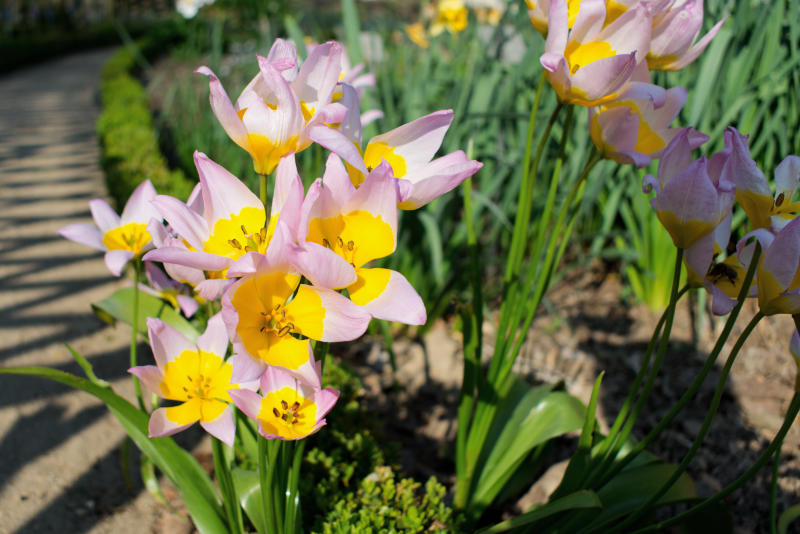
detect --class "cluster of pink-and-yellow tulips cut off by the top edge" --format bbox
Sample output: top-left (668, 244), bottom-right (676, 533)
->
top-left (527, 0), bottom-right (724, 167)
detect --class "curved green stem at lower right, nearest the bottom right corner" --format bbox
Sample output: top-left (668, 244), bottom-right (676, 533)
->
top-left (598, 312), bottom-right (764, 532)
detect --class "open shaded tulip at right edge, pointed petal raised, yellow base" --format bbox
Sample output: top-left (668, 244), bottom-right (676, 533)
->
top-left (725, 128), bottom-right (800, 230)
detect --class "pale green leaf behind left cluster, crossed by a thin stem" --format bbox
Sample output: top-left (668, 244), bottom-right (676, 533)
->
top-left (92, 287), bottom-right (199, 342)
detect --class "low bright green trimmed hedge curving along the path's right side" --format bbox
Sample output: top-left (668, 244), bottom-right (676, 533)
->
top-left (97, 30), bottom-right (195, 208)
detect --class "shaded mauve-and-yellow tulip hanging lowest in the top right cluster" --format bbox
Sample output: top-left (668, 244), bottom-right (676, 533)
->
top-left (589, 84), bottom-right (692, 167)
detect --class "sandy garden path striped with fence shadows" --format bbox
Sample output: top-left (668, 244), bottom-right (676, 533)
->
top-left (0, 50), bottom-right (169, 534)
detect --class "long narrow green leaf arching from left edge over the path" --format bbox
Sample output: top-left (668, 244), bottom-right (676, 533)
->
top-left (0, 367), bottom-right (227, 534)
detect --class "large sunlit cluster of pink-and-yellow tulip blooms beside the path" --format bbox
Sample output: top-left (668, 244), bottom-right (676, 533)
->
top-left (61, 39), bottom-right (481, 445)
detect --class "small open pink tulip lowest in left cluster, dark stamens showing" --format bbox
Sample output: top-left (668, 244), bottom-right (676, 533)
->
top-left (230, 367), bottom-right (339, 440)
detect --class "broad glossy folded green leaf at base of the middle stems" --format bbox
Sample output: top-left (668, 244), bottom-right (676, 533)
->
top-left (471, 379), bottom-right (585, 510)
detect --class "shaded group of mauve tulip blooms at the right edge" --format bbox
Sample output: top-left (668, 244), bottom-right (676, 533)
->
top-left (643, 128), bottom-right (800, 315)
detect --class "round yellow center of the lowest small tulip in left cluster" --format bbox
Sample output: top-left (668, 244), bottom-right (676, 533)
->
top-left (258, 387), bottom-right (317, 439)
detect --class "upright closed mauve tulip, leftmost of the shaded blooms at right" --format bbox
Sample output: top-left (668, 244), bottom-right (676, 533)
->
top-left (643, 128), bottom-right (734, 249)
